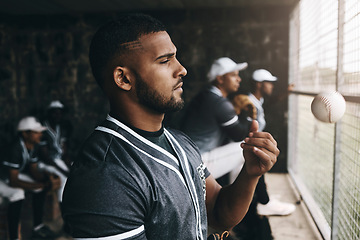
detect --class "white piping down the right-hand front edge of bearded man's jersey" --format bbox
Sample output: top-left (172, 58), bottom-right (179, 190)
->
top-left (164, 129), bottom-right (204, 240)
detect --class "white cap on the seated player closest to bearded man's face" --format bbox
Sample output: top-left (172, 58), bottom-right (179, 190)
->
top-left (208, 57), bottom-right (248, 81)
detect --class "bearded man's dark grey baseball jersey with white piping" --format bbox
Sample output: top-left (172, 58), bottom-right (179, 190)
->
top-left (63, 116), bottom-right (209, 240)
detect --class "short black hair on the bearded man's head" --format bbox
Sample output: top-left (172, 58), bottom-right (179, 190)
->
top-left (89, 13), bottom-right (166, 87)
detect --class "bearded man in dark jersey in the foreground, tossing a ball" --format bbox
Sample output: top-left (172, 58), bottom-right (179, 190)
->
top-left (63, 14), bottom-right (279, 240)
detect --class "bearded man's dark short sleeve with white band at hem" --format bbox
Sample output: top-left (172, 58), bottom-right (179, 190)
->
top-left (63, 158), bottom-right (146, 239)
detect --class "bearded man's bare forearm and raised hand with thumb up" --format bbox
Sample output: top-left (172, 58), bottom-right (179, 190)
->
top-left (206, 121), bottom-right (280, 230)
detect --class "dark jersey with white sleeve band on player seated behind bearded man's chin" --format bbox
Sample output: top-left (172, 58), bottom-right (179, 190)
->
top-left (181, 86), bottom-right (250, 153)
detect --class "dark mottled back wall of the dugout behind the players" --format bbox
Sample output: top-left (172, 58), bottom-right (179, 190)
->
top-left (0, 6), bottom-right (291, 171)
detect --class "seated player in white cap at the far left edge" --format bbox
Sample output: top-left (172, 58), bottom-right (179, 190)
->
top-left (0, 117), bottom-right (60, 240)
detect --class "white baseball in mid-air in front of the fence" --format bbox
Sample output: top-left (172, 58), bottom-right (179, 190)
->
top-left (311, 91), bottom-right (346, 123)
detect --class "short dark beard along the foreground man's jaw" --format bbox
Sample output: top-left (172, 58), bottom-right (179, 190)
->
top-left (135, 72), bottom-right (184, 113)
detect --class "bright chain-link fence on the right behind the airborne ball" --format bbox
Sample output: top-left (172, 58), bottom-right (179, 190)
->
top-left (288, 0), bottom-right (360, 240)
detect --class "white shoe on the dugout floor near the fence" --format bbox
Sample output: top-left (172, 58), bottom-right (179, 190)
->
top-left (257, 199), bottom-right (296, 216)
